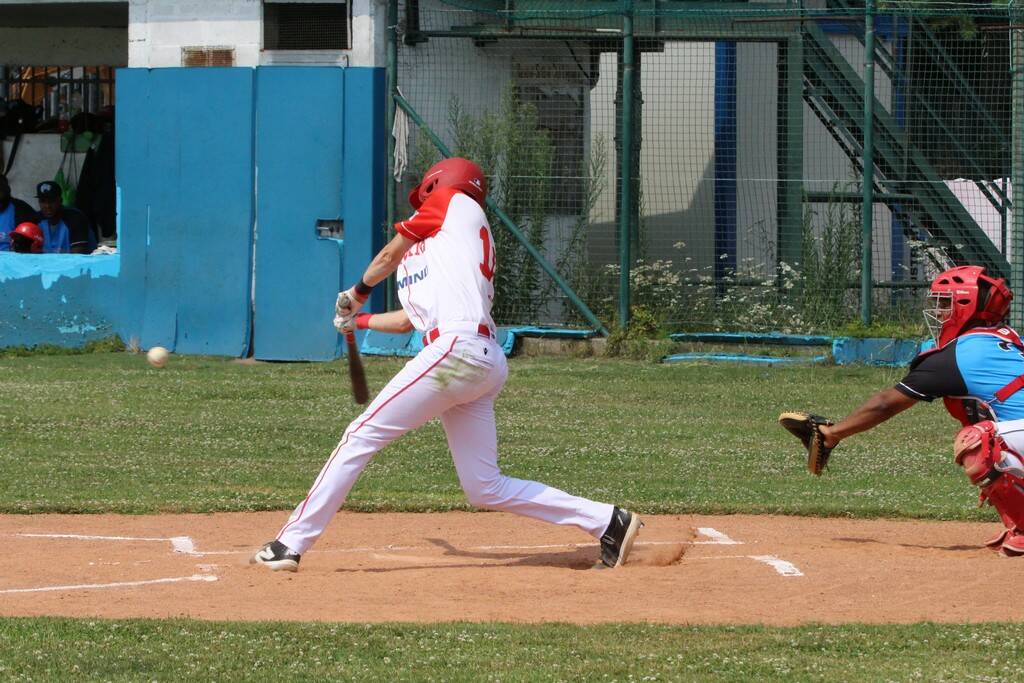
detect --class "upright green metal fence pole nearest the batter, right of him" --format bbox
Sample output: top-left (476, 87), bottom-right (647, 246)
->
top-left (618, 0), bottom-right (635, 330)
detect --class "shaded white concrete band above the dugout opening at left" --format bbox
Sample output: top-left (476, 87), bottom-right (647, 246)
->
top-left (0, 27), bottom-right (128, 67)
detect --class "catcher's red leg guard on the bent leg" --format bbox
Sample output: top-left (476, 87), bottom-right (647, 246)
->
top-left (953, 421), bottom-right (1024, 535)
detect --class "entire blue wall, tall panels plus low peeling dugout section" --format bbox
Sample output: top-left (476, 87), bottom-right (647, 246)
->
top-left (0, 67), bottom-right (385, 359)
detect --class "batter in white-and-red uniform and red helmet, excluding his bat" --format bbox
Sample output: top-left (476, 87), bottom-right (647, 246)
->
top-left (252, 158), bottom-right (642, 571)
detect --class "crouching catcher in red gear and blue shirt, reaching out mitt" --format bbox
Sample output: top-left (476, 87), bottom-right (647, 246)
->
top-left (779, 265), bottom-right (1024, 556)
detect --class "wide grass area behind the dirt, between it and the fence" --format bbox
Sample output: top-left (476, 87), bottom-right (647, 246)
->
top-left (0, 353), bottom-right (974, 519)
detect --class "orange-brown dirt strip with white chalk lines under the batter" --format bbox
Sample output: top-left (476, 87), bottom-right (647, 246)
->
top-left (0, 513), bottom-right (1024, 625)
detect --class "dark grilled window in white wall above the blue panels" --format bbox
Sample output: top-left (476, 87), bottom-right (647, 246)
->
top-left (263, 0), bottom-right (351, 51)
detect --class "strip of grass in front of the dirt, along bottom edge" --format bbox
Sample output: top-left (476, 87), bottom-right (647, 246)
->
top-left (0, 618), bottom-right (1024, 682)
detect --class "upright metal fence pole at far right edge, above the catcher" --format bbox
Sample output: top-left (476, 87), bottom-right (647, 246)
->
top-left (1007, 1), bottom-right (1024, 327)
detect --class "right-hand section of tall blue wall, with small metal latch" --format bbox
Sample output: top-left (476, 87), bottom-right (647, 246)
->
top-left (254, 67), bottom-right (384, 360)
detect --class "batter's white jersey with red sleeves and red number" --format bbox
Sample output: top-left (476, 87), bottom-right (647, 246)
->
top-left (394, 187), bottom-right (496, 333)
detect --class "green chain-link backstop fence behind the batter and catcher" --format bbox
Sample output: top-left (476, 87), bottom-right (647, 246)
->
top-left (393, 0), bottom-right (1024, 333)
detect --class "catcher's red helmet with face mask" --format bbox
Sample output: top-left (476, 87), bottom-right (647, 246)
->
top-left (925, 265), bottom-right (1014, 346)
